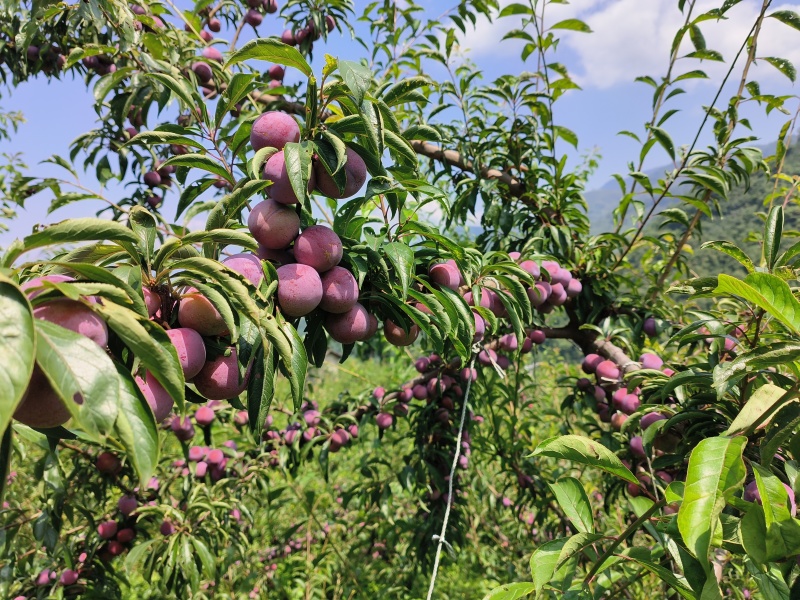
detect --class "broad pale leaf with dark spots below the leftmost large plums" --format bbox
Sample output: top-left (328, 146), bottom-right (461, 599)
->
top-left (35, 319), bottom-right (120, 442)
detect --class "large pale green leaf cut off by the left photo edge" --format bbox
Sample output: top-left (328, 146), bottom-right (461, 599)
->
top-left (0, 274), bottom-right (36, 432)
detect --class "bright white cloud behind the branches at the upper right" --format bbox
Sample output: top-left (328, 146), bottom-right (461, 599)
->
top-left (465, 0), bottom-right (800, 88)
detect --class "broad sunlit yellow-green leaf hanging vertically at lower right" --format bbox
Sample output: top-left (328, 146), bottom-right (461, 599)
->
top-left (678, 436), bottom-right (747, 570)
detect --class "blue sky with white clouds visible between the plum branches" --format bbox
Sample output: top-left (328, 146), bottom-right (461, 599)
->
top-left (0, 0), bottom-right (800, 246)
